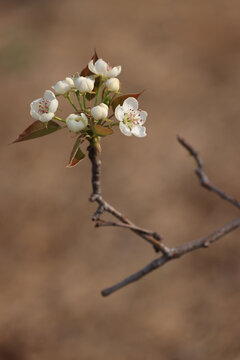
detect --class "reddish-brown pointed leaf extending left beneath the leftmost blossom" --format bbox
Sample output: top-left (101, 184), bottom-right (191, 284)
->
top-left (13, 120), bottom-right (62, 144)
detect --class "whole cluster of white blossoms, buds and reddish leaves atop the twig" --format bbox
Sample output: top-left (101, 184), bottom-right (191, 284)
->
top-left (16, 52), bottom-right (147, 166)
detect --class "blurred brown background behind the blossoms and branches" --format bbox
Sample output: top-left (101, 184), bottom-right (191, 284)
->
top-left (0, 0), bottom-right (240, 360)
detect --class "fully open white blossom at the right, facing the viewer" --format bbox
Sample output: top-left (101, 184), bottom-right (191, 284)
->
top-left (115, 97), bottom-right (147, 137)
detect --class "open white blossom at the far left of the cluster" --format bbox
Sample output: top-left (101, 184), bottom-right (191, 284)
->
top-left (30, 90), bottom-right (58, 122)
